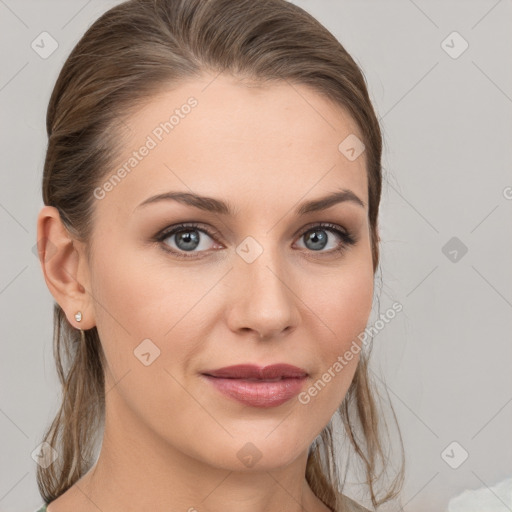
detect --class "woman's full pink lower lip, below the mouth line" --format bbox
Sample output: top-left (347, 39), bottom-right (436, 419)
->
top-left (203, 375), bottom-right (307, 407)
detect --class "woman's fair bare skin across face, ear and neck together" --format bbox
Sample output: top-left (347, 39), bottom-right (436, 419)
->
top-left (38, 75), bottom-right (373, 512)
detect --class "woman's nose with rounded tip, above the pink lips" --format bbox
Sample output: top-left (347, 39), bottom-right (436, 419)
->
top-left (227, 243), bottom-right (300, 340)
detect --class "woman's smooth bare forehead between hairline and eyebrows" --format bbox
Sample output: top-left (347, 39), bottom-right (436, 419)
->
top-left (96, 75), bottom-right (368, 216)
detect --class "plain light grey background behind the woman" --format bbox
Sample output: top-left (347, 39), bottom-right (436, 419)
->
top-left (0, 0), bottom-right (512, 512)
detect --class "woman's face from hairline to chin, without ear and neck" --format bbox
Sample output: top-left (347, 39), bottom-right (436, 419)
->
top-left (86, 75), bottom-right (373, 471)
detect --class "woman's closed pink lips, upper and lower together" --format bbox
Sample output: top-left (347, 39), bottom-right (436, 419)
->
top-left (203, 364), bottom-right (308, 407)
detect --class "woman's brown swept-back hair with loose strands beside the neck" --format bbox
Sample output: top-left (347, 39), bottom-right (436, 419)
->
top-left (37, 0), bottom-right (404, 511)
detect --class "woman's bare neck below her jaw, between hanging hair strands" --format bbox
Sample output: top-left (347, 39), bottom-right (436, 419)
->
top-left (70, 392), bottom-right (329, 512)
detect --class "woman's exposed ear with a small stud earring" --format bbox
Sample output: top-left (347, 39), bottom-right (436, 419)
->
top-left (37, 206), bottom-right (96, 330)
